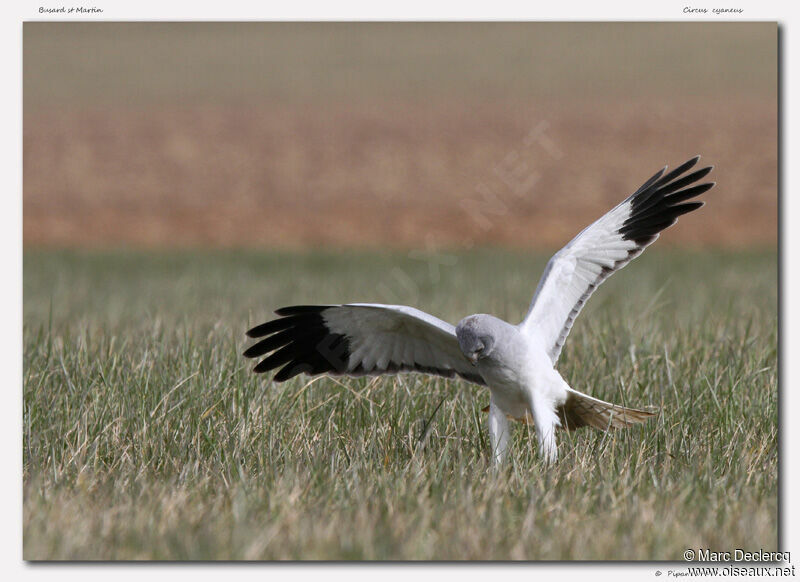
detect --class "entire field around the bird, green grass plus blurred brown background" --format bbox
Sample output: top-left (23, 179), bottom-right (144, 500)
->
top-left (23, 23), bottom-right (778, 560)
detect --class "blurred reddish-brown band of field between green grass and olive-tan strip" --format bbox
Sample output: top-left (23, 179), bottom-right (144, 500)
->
top-left (24, 100), bottom-right (777, 248)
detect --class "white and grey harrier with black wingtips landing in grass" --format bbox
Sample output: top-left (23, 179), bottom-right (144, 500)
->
top-left (244, 156), bottom-right (714, 463)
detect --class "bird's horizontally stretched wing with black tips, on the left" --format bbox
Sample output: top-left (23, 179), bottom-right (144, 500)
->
top-left (244, 303), bottom-right (485, 385)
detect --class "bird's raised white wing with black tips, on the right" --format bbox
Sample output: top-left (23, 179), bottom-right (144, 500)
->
top-left (520, 156), bottom-right (714, 364)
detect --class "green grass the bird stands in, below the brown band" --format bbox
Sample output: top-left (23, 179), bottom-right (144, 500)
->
top-left (23, 248), bottom-right (778, 560)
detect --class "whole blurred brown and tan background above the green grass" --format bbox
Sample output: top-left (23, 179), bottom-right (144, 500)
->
top-left (23, 23), bottom-right (778, 249)
